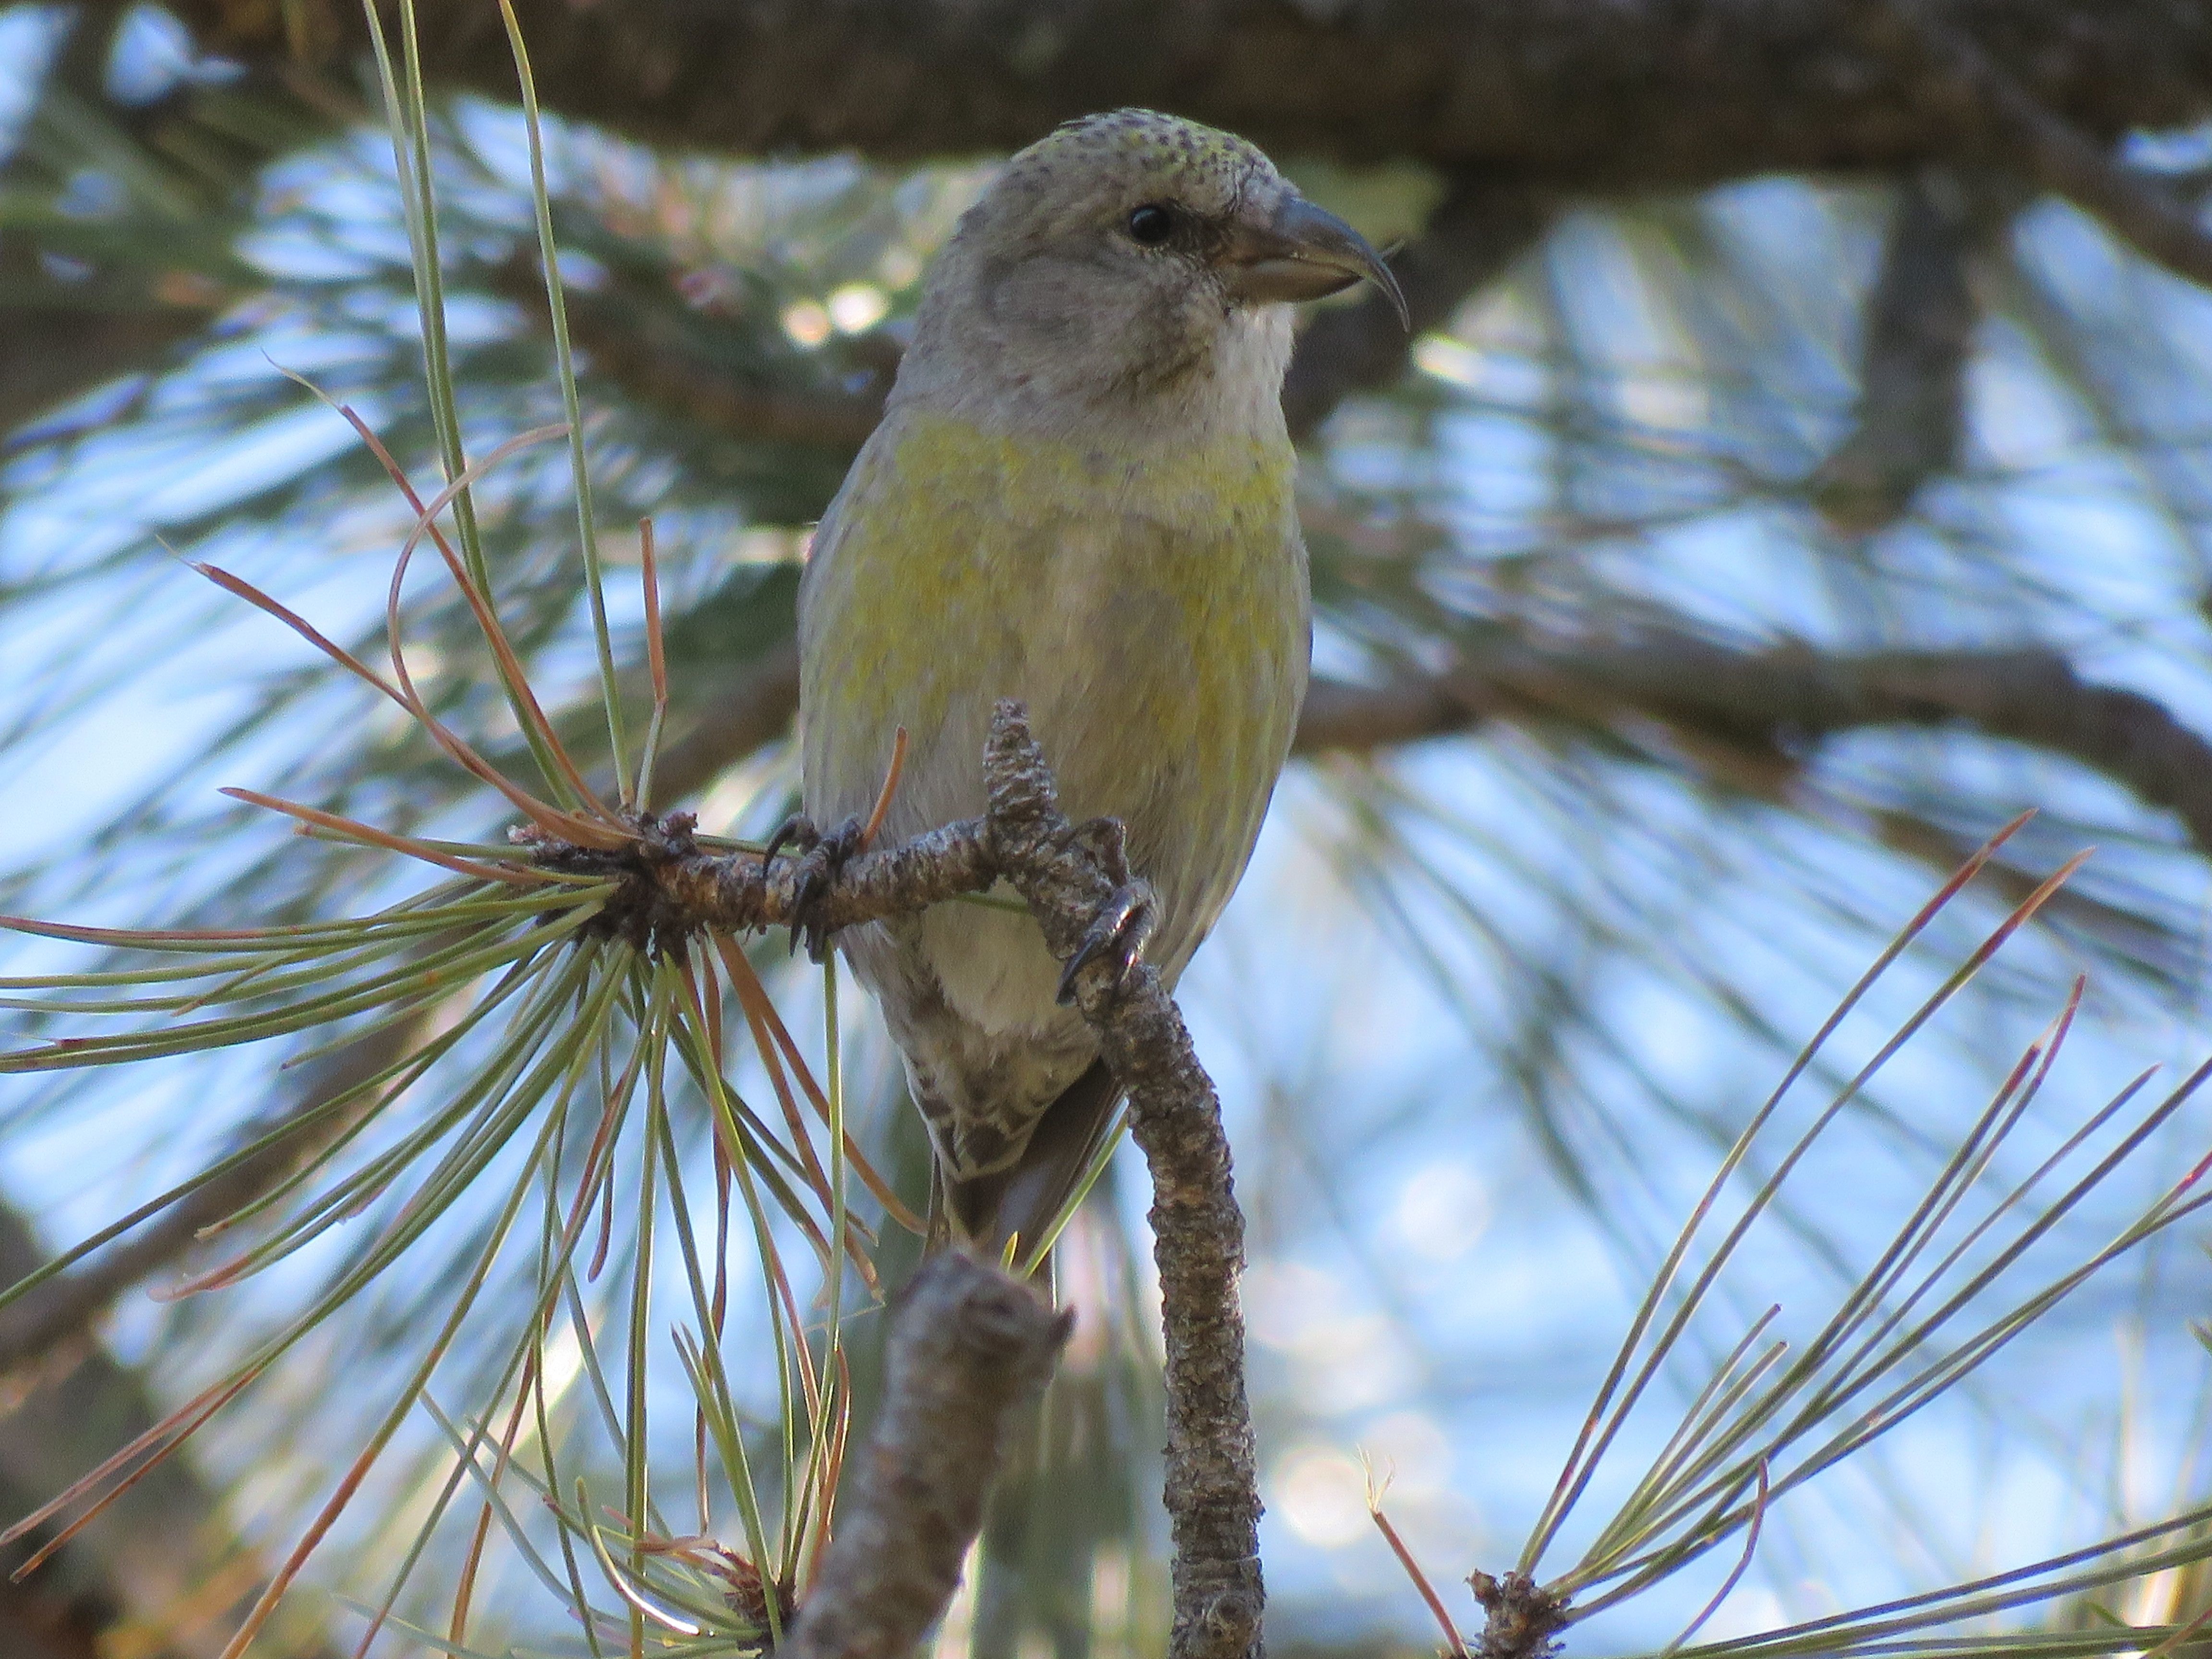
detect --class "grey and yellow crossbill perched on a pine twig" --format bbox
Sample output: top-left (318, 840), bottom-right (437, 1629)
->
top-left (798, 110), bottom-right (1405, 1250)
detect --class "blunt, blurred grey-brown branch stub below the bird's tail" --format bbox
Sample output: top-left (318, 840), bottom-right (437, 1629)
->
top-left (781, 1252), bottom-right (1073, 1659)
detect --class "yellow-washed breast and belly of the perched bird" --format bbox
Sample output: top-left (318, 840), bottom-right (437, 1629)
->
top-left (801, 409), bottom-right (1310, 947)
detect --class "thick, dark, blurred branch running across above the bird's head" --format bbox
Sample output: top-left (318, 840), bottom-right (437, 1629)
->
top-left (143, 0), bottom-right (2212, 188)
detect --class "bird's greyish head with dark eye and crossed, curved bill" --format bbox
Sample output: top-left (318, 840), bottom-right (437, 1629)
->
top-left (909, 108), bottom-right (1405, 429)
